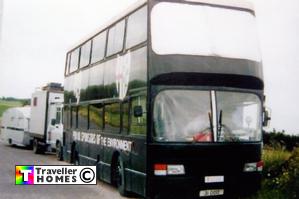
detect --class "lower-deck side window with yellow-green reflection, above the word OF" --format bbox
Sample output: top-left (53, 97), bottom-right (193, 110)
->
top-left (89, 104), bottom-right (103, 130)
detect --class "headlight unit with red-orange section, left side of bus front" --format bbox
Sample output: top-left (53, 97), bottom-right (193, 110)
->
top-left (154, 164), bottom-right (185, 176)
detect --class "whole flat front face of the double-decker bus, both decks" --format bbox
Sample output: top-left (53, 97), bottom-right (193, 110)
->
top-left (147, 0), bottom-right (264, 198)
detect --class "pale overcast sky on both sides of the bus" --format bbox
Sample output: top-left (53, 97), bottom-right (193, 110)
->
top-left (0, 0), bottom-right (299, 134)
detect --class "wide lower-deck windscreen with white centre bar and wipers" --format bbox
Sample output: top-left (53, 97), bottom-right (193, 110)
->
top-left (154, 90), bottom-right (261, 142)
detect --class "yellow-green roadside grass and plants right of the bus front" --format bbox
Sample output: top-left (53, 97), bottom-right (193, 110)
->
top-left (250, 145), bottom-right (299, 199)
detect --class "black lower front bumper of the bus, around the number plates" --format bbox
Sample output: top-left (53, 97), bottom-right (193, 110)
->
top-left (148, 172), bottom-right (261, 199)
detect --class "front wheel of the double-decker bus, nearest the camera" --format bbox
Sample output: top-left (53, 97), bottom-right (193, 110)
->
top-left (115, 157), bottom-right (129, 196)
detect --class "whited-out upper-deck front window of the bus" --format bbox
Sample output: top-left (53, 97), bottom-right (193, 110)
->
top-left (151, 1), bottom-right (261, 62)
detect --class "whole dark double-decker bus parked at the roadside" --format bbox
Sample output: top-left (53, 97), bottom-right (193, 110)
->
top-left (64, 0), bottom-right (267, 198)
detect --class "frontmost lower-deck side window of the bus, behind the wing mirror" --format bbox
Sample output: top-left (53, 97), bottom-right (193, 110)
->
top-left (130, 96), bottom-right (147, 135)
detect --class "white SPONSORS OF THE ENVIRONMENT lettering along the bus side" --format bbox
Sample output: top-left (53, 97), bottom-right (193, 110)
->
top-left (73, 131), bottom-right (133, 152)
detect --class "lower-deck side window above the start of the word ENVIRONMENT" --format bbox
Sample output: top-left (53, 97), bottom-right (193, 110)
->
top-left (104, 103), bottom-right (120, 133)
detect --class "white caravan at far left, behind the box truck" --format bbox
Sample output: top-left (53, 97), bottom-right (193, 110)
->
top-left (1, 106), bottom-right (31, 146)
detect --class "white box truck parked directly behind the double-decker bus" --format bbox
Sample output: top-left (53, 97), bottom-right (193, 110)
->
top-left (29, 83), bottom-right (64, 160)
